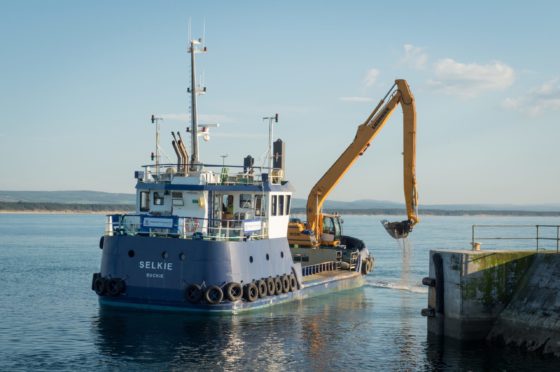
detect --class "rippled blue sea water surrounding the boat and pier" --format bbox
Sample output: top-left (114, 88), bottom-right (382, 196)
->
top-left (0, 214), bottom-right (560, 371)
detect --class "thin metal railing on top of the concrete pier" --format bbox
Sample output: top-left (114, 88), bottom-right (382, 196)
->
top-left (471, 225), bottom-right (560, 253)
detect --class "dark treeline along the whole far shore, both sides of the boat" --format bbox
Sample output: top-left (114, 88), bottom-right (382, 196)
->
top-left (0, 201), bottom-right (560, 217)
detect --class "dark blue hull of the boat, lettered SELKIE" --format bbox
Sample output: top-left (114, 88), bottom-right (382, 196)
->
top-left (92, 235), bottom-right (369, 314)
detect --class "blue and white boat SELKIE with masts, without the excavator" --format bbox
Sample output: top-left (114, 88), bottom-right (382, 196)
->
top-left (91, 39), bottom-right (373, 313)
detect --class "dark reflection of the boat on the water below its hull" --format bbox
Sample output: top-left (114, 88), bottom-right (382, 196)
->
top-left (92, 289), bottom-right (372, 369)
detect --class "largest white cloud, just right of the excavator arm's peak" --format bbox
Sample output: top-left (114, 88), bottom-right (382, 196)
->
top-left (429, 58), bottom-right (515, 97)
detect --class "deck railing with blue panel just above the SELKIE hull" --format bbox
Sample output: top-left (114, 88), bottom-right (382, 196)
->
top-left (105, 214), bottom-right (268, 241)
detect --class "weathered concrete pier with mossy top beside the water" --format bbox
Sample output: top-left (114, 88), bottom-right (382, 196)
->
top-left (422, 250), bottom-right (560, 356)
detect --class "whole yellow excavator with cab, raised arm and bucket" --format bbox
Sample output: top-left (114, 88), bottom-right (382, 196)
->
top-left (288, 79), bottom-right (419, 248)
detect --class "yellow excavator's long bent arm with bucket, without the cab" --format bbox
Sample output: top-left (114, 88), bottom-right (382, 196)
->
top-left (307, 80), bottom-right (418, 238)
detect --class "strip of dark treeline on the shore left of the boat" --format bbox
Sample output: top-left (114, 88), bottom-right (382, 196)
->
top-left (0, 201), bottom-right (134, 213)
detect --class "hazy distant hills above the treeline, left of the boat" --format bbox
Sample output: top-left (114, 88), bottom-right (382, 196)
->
top-left (0, 191), bottom-right (135, 205)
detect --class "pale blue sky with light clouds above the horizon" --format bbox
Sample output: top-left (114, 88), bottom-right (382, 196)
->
top-left (0, 0), bottom-right (560, 204)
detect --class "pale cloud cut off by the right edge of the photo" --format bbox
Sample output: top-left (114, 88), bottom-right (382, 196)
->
top-left (502, 79), bottom-right (560, 115)
